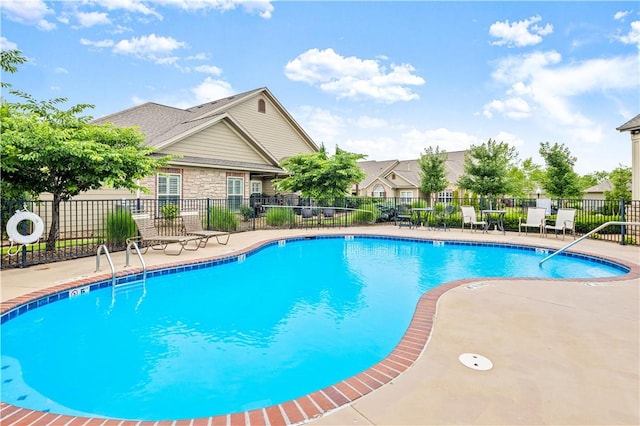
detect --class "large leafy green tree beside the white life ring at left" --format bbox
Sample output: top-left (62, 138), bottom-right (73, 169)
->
top-left (0, 92), bottom-right (169, 250)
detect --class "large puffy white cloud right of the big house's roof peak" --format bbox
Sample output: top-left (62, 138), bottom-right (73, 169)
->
top-left (285, 49), bottom-right (424, 103)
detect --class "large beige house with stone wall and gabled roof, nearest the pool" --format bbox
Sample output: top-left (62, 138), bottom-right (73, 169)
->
top-left (60, 88), bottom-right (318, 211)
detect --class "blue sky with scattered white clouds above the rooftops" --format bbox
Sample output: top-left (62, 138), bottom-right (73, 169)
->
top-left (0, 0), bottom-right (640, 174)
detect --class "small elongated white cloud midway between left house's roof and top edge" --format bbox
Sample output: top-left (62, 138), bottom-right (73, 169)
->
top-left (113, 34), bottom-right (187, 64)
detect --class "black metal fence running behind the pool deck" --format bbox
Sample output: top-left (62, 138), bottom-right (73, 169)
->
top-left (0, 195), bottom-right (640, 268)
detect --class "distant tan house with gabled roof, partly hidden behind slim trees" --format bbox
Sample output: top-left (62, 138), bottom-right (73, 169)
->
top-left (352, 151), bottom-right (466, 203)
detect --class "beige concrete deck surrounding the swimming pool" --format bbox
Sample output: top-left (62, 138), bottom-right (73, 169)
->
top-left (0, 225), bottom-right (640, 425)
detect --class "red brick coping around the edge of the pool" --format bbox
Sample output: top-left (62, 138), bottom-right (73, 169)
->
top-left (0, 234), bottom-right (640, 426)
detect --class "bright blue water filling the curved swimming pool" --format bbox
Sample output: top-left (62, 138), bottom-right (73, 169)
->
top-left (1, 237), bottom-right (626, 420)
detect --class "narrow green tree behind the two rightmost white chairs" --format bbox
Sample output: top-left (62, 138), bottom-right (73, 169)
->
top-left (540, 142), bottom-right (582, 198)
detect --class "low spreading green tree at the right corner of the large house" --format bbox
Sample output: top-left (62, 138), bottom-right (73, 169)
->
top-left (274, 145), bottom-right (365, 200)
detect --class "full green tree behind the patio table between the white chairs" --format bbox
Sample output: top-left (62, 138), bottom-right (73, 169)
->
top-left (458, 139), bottom-right (517, 206)
